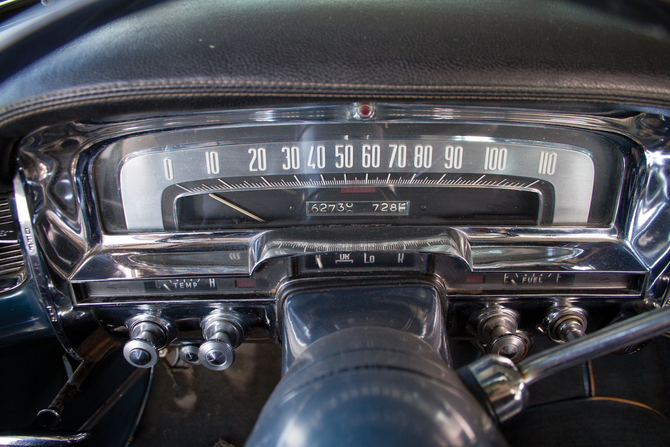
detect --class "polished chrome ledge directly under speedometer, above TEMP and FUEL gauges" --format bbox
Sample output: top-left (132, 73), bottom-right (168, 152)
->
top-left (61, 227), bottom-right (632, 282)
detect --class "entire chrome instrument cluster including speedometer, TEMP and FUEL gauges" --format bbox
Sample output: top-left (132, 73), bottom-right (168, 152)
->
top-left (16, 102), bottom-right (656, 342)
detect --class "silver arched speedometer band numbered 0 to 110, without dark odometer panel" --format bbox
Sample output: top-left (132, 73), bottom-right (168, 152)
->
top-left (107, 126), bottom-right (600, 233)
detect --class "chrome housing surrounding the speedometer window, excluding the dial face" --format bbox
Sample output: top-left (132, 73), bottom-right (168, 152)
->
top-left (15, 103), bottom-right (669, 357)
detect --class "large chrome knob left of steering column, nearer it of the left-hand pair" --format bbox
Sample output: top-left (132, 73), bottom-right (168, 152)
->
top-left (198, 315), bottom-right (244, 371)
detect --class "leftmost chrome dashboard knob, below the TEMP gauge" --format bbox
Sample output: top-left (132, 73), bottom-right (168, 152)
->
top-left (123, 321), bottom-right (167, 368)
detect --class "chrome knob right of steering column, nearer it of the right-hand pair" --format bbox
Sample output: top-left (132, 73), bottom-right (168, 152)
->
top-left (472, 306), bottom-right (531, 362)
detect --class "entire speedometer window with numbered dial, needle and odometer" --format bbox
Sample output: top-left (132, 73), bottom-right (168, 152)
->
top-left (96, 124), bottom-right (622, 231)
